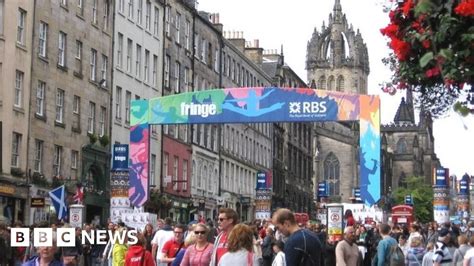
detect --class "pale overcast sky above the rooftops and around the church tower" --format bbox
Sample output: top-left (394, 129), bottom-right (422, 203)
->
top-left (197, 0), bottom-right (474, 177)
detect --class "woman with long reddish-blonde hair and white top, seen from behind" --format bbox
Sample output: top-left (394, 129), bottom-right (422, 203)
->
top-left (218, 224), bottom-right (259, 266)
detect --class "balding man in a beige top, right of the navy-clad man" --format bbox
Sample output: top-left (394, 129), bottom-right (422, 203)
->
top-left (336, 226), bottom-right (359, 266)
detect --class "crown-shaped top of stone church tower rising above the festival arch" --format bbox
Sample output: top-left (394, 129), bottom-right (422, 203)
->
top-left (306, 0), bottom-right (370, 94)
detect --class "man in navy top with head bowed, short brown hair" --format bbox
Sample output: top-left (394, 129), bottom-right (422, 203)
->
top-left (273, 208), bottom-right (321, 266)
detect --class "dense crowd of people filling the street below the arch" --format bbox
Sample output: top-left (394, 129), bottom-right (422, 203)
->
top-left (0, 208), bottom-right (474, 266)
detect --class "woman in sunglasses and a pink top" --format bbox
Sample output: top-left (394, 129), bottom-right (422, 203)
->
top-left (181, 224), bottom-right (214, 266)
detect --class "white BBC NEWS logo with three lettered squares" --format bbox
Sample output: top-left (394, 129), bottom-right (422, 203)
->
top-left (10, 228), bottom-right (138, 247)
